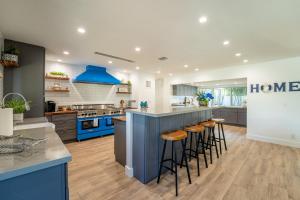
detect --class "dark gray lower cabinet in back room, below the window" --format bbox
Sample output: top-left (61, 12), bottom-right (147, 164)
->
top-left (212, 108), bottom-right (247, 126)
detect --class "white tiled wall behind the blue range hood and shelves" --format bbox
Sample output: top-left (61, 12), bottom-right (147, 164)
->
top-left (45, 61), bottom-right (155, 108)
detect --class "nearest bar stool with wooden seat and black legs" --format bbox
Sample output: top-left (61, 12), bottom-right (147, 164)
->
top-left (157, 130), bottom-right (192, 196)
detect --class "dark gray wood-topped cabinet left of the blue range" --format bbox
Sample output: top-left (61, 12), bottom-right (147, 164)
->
top-left (47, 113), bottom-right (77, 141)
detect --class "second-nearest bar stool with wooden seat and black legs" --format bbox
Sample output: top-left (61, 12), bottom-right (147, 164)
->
top-left (180, 125), bottom-right (208, 176)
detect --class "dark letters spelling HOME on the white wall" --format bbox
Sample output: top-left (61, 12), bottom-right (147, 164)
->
top-left (250, 81), bottom-right (300, 93)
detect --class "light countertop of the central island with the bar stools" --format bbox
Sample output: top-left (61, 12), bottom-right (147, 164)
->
top-left (126, 106), bottom-right (215, 117)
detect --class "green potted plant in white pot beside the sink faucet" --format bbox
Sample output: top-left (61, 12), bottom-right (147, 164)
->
top-left (5, 99), bottom-right (26, 121)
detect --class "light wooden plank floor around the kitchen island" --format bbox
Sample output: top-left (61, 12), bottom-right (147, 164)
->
top-left (67, 126), bottom-right (300, 200)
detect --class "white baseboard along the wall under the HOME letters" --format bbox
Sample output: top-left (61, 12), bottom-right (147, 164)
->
top-left (247, 133), bottom-right (300, 148)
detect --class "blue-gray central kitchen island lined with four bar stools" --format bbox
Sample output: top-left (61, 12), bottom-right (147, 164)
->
top-left (125, 106), bottom-right (213, 184)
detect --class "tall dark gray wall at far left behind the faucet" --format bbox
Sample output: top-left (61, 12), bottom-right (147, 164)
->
top-left (3, 39), bottom-right (45, 117)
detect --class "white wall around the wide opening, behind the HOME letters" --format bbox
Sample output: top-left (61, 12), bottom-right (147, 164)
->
top-left (160, 57), bottom-right (300, 147)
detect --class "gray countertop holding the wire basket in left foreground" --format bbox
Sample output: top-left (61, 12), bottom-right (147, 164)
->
top-left (0, 127), bottom-right (71, 181)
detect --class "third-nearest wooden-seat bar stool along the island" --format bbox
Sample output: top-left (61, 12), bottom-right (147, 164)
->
top-left (200, 121), bottom-right (219, 164)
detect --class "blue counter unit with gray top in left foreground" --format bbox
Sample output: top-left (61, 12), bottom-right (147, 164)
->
top-left (0, 127), bottom-right (71, 200)
